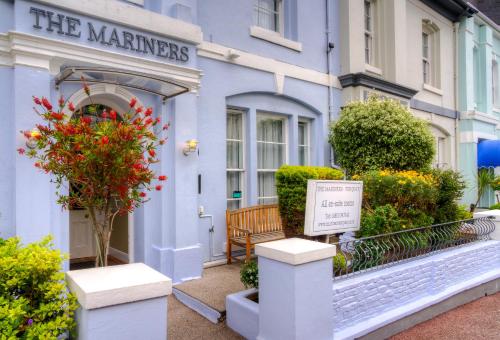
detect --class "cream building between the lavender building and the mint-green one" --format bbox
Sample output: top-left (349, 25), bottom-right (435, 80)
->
top-left (339, 0), bottom-right (475, 173)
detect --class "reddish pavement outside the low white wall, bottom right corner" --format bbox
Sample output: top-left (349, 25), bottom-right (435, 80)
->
top-left (391, 293), bottom-right (500, 340)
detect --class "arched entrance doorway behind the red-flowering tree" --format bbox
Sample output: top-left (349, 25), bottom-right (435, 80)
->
top-left (69, 88), bottom-right (140, 270)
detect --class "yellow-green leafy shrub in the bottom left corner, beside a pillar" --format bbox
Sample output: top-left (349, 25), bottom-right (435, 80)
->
top-left (0, 237), bottom-right (77, 339)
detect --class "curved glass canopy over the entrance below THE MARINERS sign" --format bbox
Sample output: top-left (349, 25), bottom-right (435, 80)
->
top-left (55, 66), bottom-right (191, 100)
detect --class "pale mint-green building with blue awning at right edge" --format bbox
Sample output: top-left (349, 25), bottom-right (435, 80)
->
top-left (457, 1), bottom-right (500, 207)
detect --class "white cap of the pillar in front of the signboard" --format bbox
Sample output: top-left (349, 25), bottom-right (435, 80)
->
top-left (255, 238), bottom-right (335, 266)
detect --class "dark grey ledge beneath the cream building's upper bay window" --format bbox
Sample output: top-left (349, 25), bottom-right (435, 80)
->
top-left (339, 72), bottom-right (418, 99)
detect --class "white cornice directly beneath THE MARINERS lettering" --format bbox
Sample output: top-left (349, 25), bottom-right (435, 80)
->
top-left (0, 31), bottom-right (201, 91)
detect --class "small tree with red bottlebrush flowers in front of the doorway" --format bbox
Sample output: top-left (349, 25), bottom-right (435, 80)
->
top-left (17, 84), bottom-right (169, 267)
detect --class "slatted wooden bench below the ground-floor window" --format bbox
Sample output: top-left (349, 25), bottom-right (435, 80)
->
top-left (226, 204), bottom-right (285, 264)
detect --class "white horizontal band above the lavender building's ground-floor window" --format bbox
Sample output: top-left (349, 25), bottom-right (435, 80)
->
top-left (198, 41), bottom-right (342, 89)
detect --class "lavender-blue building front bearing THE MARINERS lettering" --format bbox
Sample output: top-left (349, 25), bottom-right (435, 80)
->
top-left (0, 0), bottom-right (340, 282)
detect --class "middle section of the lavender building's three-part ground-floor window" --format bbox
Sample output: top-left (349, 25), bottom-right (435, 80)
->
top-left (257, 114), bottom-right (287, 204)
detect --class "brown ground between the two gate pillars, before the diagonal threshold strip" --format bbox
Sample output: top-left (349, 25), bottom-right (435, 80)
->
top-left (168, 295), bottom-right (243, 340)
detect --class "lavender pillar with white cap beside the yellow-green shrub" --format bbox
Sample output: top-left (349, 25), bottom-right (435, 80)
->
top-left (66, 263), bottom-right (172, 340)
